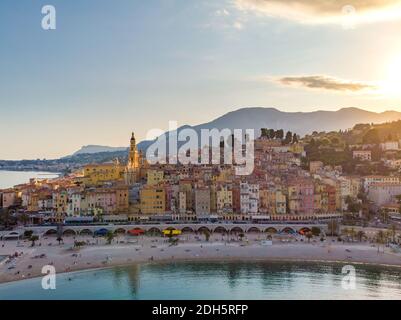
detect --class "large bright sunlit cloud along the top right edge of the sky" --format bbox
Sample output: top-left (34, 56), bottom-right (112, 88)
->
top-left (233, 0), bottom-right (401, 24)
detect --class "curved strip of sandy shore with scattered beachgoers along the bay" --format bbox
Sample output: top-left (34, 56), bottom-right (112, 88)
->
top-left (0, 235), bottom-right (401, 284)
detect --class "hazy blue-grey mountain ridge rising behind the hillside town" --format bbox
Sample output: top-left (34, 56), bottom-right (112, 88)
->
top-left (138, 108), bottom-right (401, 150)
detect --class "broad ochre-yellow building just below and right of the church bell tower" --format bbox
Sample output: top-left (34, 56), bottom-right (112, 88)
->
top-left (140, 186), bottom-right (166, 214)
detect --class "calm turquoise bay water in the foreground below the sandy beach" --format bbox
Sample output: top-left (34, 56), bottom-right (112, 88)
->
top-left (0, 262), bottom-right (401, 300)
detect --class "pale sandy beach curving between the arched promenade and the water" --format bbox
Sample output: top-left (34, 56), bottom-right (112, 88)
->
top-left (0, 235), bottom-right (401, 283)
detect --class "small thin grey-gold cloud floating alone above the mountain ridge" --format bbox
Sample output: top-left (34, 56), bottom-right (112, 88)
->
top-left (275, 75), bottom-right (376, 92)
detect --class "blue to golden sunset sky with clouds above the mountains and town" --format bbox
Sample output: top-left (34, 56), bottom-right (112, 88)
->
top-left (0, 0), bottom-right (401, 159)
